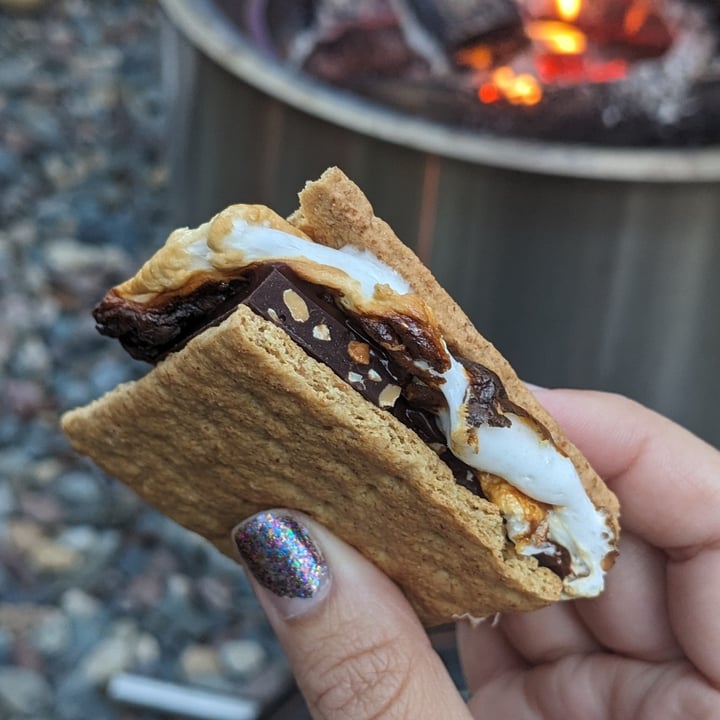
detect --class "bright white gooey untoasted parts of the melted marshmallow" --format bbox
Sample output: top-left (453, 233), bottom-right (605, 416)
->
top-left (193, 219), bottom-right (614, 597)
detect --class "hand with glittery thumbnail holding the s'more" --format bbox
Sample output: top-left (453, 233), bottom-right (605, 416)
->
top-left (232, 390), bottom-right (720, 720)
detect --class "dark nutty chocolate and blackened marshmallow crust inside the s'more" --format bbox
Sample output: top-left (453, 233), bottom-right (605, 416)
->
top-left (93, 263), bottom-right (570, 577)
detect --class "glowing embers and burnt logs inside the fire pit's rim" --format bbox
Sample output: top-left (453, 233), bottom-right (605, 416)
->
top-left (226, 0), bottom-right (720, 147)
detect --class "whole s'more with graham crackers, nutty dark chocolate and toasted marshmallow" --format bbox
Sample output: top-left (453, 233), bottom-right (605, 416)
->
top-left (62, 168), bottom-right (619, 626)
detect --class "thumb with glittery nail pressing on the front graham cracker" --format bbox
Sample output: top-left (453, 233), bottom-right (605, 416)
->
top-left (233, 510), bottom-right (470, 720)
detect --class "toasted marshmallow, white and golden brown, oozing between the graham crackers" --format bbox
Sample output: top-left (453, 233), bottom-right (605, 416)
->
top-left (120, 216), bottom-right (616, 598)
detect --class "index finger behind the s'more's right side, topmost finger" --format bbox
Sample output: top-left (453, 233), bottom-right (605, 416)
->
top-left (533, 388), bottom-right (720, 550)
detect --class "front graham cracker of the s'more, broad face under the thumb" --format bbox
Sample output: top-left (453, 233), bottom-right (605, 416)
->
top-left (62, 306), bottom-right (562, 625)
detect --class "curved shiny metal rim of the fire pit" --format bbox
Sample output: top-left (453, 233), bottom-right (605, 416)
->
top-left (160, 0), bottom-right (720, 183)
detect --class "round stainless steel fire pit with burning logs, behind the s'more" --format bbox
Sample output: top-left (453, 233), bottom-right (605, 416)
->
top-left (156, 0), bottom-right (720, 443)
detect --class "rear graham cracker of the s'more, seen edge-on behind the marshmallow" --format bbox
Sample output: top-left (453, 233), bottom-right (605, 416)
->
top-left (288, 168), bottom-right (620, 537)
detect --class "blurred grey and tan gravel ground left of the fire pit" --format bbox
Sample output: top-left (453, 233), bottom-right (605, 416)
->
top-left (0, 0), bottom-right (298, 720)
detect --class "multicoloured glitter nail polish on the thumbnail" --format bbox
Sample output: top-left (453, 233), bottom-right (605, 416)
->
top-left (233, 512), bottom-right (328, 598)
